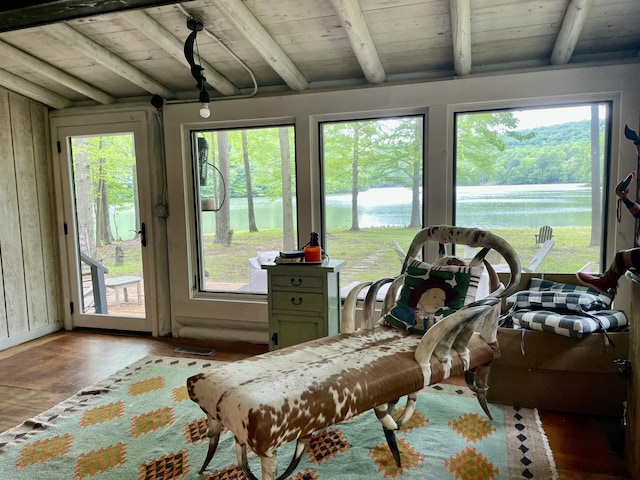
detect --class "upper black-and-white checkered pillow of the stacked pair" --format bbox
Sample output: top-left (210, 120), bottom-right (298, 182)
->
top-left (507, 278), bottom-right (613, 313)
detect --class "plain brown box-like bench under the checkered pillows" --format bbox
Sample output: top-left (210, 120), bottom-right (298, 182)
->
top-left (487, 328), bottom-right (629, 417)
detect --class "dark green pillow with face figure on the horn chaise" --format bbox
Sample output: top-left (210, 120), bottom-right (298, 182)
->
top-left (383, 258), bottom-right (484, 334)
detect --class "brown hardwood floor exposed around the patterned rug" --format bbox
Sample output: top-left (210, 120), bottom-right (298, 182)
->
top-left (0, 330), bottom-right (631, 480)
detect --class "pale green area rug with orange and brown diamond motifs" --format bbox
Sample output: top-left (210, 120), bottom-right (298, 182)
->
top-left (0, 357), bottom-right (557, 480)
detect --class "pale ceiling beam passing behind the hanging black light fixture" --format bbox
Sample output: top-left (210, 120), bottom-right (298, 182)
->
top-left (120, 10), bottom-right (240, 96)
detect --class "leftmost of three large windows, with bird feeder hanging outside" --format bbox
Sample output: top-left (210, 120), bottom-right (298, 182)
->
top-left (192, 125), bottom-right (298, 293)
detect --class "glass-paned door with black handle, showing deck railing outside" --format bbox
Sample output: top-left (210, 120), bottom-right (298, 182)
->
top-left (56, 124), bottom-right (151, 331)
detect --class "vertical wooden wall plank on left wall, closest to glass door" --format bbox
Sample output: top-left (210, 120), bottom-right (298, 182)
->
top-left (30, 103), bottom-right (63, 325)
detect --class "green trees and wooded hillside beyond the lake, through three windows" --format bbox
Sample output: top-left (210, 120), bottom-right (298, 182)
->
top-left (219, 114), bottom-right (605, 198)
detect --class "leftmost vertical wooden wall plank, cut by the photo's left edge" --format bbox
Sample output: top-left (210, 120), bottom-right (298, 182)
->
top-left (0, 89), bottom-right (29, 337)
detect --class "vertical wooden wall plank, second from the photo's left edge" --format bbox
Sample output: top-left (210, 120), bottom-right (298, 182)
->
top-left (9, 94), bottom-right (48, 330)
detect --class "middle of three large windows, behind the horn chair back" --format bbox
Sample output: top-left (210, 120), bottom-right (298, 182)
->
top-left (320, 115), bottom-right (424, 294)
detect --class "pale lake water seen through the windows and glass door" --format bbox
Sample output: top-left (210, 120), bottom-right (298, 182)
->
top-left (112, 184), bottom-right (591, 235)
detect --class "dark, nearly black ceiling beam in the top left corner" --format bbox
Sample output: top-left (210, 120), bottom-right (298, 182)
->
top-left (0, 0), bottom-right (175, 32)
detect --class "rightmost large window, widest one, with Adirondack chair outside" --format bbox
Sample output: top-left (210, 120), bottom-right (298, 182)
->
top-left (454, 103), bottom-right (610, 273)
